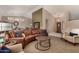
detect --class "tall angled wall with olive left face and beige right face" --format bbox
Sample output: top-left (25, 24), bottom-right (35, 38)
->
top-left (32, 8), bottom-right (56, 32)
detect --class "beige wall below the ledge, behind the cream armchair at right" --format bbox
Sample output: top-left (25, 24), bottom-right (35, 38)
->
top-left (63, 20), bottom-right (79, 33)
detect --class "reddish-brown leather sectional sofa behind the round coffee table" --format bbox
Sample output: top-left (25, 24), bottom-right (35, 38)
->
top-left (5, 29), bottom-right (40, 48)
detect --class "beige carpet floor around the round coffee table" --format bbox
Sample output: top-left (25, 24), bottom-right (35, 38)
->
top-left (24, 36), bottom-right (79, 53)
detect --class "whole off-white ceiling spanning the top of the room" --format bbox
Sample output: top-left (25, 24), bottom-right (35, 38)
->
top-left (0, 5), bottom-right (79, 19)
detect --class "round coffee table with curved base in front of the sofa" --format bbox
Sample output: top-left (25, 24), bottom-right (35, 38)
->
top-left (35, 36), bottom-right (50, 51)
